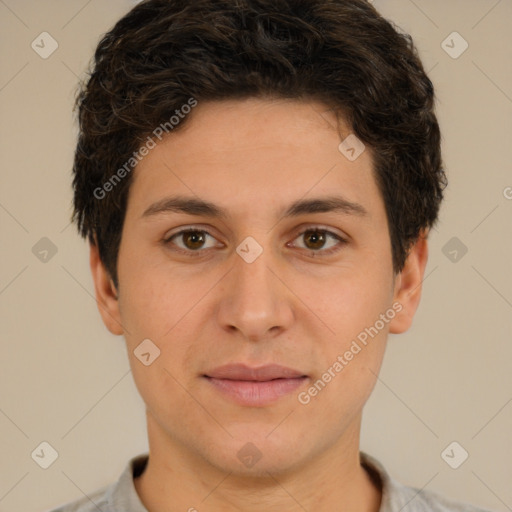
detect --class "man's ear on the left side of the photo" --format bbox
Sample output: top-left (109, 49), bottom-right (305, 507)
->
top-left (89, 243), bottom-right (124, 335)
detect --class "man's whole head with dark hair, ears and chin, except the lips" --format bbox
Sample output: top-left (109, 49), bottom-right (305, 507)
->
top-left (74, 0), bottom-right (446, 471)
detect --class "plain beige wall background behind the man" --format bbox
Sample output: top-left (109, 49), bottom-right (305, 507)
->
top-left (0, 0), bottom-right (512, 512)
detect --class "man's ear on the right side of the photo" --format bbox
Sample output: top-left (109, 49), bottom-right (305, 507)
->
top-left (389, 231), bottom-right (428, 334)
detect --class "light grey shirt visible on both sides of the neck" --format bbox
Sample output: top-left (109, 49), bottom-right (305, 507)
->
top-left (50, 452), bottom-right (494, 512)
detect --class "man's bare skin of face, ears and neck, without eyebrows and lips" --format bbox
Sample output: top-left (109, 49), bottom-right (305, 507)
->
top-left (90, 98), bottom-right (428, 512)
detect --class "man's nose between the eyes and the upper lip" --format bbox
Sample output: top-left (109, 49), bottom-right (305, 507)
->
top-left (218, 245), bottom-right (294, 341)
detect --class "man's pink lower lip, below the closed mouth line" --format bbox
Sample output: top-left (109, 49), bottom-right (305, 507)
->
top-left (206, 377), bottom-right (308, 407)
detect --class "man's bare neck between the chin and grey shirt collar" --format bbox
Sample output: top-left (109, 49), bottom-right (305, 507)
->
top-left (134, 415), bottom-right (381, 512)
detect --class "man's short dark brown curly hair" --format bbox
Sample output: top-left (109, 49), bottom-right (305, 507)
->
top-left (73, 0), bottom-right (447, 286)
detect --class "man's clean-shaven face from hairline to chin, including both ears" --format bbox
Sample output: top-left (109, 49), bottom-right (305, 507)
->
top-left (91, 99), bottom-right (426, 473)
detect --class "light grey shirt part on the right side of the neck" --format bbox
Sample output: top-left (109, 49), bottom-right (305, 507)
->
top-left (360, 452), bottom-right (496, 512)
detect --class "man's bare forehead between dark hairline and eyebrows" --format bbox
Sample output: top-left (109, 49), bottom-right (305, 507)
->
top-left (129, 99), bottom-right (383, 224)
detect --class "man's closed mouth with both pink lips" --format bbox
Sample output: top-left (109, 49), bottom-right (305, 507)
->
top-left (202, 364), bottom-right (309, 407)
